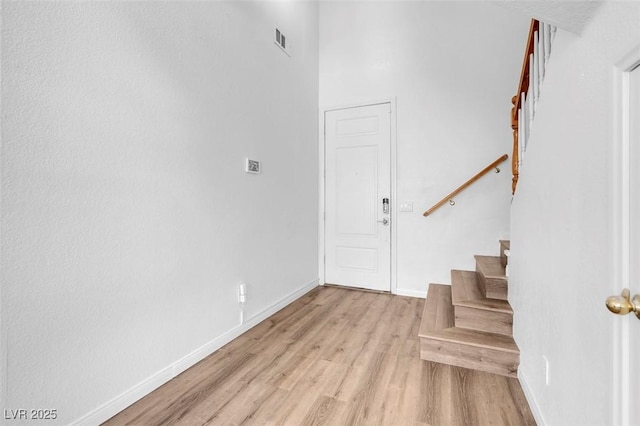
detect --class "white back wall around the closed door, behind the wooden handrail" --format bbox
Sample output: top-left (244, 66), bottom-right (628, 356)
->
top-left (320, 1), bottom-right (530, 297)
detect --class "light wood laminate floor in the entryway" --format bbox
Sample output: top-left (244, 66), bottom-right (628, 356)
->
top-left (105, 286), bottom-right (535, 426)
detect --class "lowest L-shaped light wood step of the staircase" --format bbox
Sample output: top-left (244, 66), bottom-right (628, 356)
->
top-left (419, 284), bottom-right (520, 377)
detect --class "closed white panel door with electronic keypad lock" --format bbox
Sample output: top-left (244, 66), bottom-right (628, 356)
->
top-left (325, 103), bottom-right (393, 291)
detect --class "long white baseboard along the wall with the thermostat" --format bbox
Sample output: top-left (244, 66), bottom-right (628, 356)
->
top-left (71, 280), bottom-right (318, 426)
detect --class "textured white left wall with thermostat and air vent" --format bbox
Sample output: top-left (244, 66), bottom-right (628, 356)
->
top-left (0, 2), bottom-right (318, 424)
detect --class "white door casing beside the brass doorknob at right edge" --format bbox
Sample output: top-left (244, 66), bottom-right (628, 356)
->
top-left (610, 45), bottom-right (640, 426)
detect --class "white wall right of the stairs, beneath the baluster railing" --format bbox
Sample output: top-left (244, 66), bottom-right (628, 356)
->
top-left (509, 2), bottom-right (640, 425)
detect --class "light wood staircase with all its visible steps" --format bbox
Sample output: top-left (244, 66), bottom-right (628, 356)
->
top-left (419, 241), bottom-right (520, 377)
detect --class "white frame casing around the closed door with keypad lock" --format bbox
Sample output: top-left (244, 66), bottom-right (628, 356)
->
top-left (318, 97), bottom-right (398, 294)
